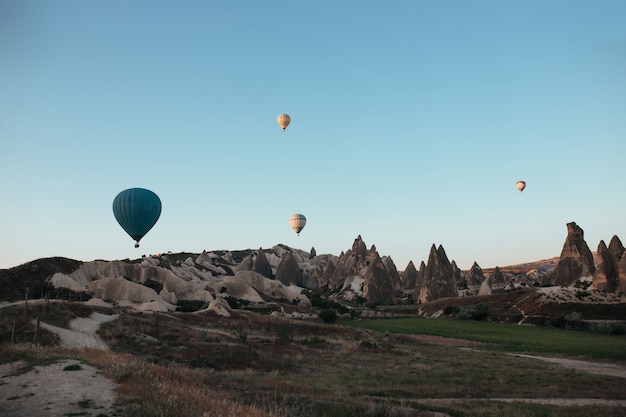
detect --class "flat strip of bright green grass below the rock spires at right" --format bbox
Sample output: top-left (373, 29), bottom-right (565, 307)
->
top-left (341, 318), bottom-right (626, 362)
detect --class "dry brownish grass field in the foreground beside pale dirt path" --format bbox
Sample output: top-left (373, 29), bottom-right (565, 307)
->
top-left (0, 302), bottom-right (625, 417)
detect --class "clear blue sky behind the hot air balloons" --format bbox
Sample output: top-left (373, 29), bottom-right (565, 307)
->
top-left (0, 0), bottom-right (626, 270)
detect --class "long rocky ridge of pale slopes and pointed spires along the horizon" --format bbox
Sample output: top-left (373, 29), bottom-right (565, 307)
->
top-left (0, 223), bottom-right (626, 313)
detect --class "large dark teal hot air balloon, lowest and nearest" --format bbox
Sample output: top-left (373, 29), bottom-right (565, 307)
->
top-left (113, 188), bottom-right (161, 248)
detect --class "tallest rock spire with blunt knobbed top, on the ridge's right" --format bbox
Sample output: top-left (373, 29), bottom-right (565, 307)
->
top-left (541, 222), bottom-right (595, 286)
